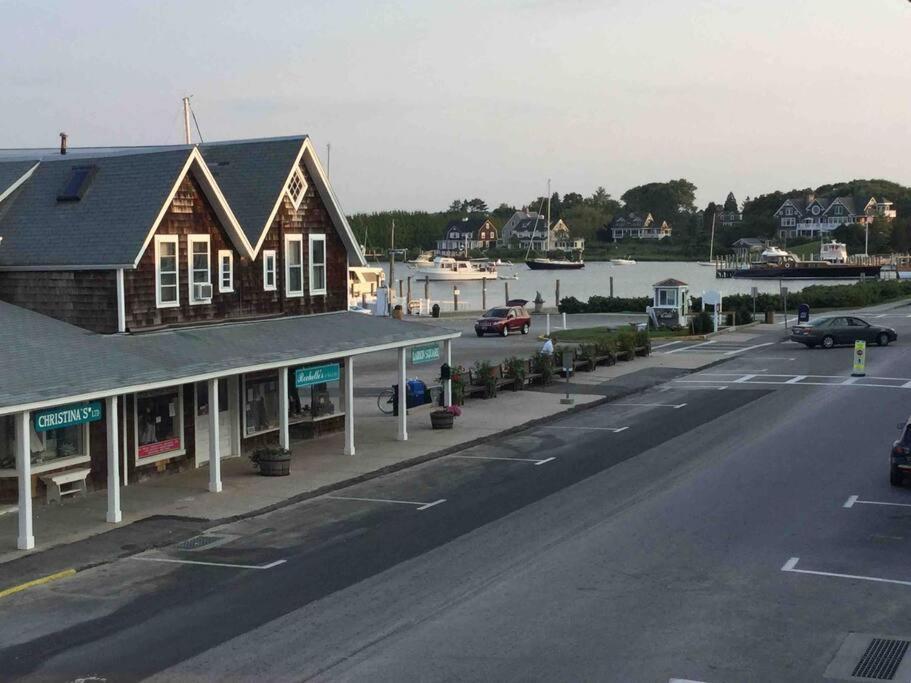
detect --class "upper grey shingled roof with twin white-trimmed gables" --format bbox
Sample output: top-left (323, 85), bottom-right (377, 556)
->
top-left (0, 135), bottom-right (365, 268)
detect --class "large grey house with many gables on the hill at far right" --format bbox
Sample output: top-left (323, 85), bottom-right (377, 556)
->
top-left (775, 194), bottom-right (895, 237)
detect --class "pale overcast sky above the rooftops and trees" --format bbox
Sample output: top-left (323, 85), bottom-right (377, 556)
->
top-left (0, 0), bottom-right (911, 212)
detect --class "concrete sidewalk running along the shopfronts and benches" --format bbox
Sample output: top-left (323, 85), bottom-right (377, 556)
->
top-left (0, 344), bottom-right (740, 593)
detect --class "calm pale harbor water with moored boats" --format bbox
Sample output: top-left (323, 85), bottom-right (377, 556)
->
top-left (378, 261), bottom-right (854, 310)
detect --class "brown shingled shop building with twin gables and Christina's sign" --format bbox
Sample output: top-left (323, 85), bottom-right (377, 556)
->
top-left (0, 136), bottom-right (456, 548)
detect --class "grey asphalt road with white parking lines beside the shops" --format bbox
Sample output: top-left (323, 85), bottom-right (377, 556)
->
top-left (0, 309), bottom-right (911, 683)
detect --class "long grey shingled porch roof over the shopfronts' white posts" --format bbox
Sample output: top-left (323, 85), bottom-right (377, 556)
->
top-left (0, 302), bottom-right (461, 415)
